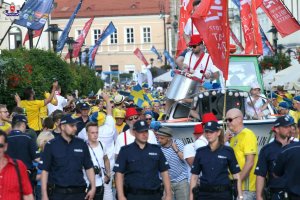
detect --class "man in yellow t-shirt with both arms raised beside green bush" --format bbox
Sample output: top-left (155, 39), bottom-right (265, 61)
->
top-left (15, 81), bottom-right (58, 132)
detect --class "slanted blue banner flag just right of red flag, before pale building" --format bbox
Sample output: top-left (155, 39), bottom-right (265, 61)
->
top-left (89, 22), bottom-right (117, 67)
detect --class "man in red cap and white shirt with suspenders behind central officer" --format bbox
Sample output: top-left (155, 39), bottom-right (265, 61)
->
top-left (115, 107), bottom-right (157, 157)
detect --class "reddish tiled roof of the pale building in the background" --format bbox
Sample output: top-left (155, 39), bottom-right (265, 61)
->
top-left (51, 0), bottom-right (170, 19)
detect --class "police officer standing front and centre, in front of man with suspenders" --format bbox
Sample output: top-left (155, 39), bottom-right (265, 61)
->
top-left (114, 120), bottom-right (172, 200)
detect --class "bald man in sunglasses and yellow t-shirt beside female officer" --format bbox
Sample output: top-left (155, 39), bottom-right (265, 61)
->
top-left (225, 108), bottom-right (258, 200)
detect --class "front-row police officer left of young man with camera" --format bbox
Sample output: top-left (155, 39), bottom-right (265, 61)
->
top-left (39, 115), bottom-right (96, 200)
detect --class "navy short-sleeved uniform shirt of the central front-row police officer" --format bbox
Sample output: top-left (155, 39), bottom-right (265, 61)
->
top-left (113, 142), bottom-right (170, 190)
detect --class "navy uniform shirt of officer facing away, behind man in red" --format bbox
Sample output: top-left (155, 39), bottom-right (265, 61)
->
top-left (7, 130), bottom-right (40, 169)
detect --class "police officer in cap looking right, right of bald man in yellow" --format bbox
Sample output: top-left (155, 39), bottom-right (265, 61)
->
top-left (254, 116), bottom-right (293, 200)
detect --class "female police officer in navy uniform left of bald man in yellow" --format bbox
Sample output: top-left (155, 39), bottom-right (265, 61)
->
top-left (190, 121), bottom-right (243, 200)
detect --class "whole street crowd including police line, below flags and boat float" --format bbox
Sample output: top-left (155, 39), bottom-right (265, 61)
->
top-left (0, 77), bottom-right (300, 200)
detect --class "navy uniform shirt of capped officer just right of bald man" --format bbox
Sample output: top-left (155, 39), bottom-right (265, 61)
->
top-left (254, 139), bottom-right (286, 189)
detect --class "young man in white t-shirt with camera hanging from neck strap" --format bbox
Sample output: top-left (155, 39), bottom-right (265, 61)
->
top-left (84, 122), bottom-right (111, 200)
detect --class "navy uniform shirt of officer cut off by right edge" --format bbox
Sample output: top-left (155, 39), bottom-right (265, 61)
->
top-left (274, 142), bottom-right (300, 196)
